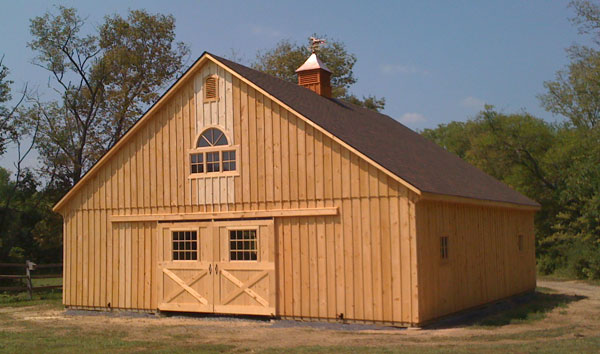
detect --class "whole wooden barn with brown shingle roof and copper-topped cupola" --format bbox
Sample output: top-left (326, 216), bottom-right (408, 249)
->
top-left (54, 53), bottom-right (539, 326)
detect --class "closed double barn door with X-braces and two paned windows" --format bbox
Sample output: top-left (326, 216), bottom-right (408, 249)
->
top-left (158, 220), bottom-right (275, 315)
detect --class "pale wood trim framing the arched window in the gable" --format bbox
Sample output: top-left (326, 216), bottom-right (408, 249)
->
top-left (190, 124), bottom-right (241, 179)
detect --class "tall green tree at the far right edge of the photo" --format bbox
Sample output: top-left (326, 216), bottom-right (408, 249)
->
top-left (540, 0), bottom-right (600, 278)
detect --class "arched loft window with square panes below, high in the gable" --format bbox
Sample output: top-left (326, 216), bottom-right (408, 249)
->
top-left (189, 127), bottom-right (239, 178)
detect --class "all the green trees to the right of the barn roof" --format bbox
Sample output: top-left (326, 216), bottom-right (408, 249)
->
top-left (422, 1), bottom-right (600, 279)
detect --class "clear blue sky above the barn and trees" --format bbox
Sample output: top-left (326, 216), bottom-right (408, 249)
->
top-left (0, 0), bottom-right (584, 171)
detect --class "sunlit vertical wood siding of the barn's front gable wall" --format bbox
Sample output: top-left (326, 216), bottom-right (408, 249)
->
top-left (62, 58), bottom-right (420, 324)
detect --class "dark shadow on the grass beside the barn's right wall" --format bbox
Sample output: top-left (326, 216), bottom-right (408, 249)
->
top-left (426, 288), bottom-right (586, 329)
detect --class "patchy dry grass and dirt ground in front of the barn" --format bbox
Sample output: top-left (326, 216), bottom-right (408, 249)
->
top-left (0, 281), bottom-right (600, 353)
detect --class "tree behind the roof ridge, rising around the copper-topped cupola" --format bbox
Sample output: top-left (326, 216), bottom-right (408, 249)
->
top-left (251, 34), bottom-right (385, 111)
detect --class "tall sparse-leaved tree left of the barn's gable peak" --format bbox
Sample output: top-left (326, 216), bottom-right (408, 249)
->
top-left (28, 6), bottom-right (189, 187)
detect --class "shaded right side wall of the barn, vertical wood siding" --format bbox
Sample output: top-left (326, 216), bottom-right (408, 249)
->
top-left (417, 201), bottom-right (536, 322)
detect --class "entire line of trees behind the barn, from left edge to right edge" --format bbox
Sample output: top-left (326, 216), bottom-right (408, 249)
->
top-left (0, 0), bottom-right (600, 279)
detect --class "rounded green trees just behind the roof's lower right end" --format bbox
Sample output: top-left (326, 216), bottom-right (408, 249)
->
top-left (422, 106), bottom-right (560, 254)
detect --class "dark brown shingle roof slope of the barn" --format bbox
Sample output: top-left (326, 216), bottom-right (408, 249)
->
top-left (211, 54), bottom-right (539, 206)
